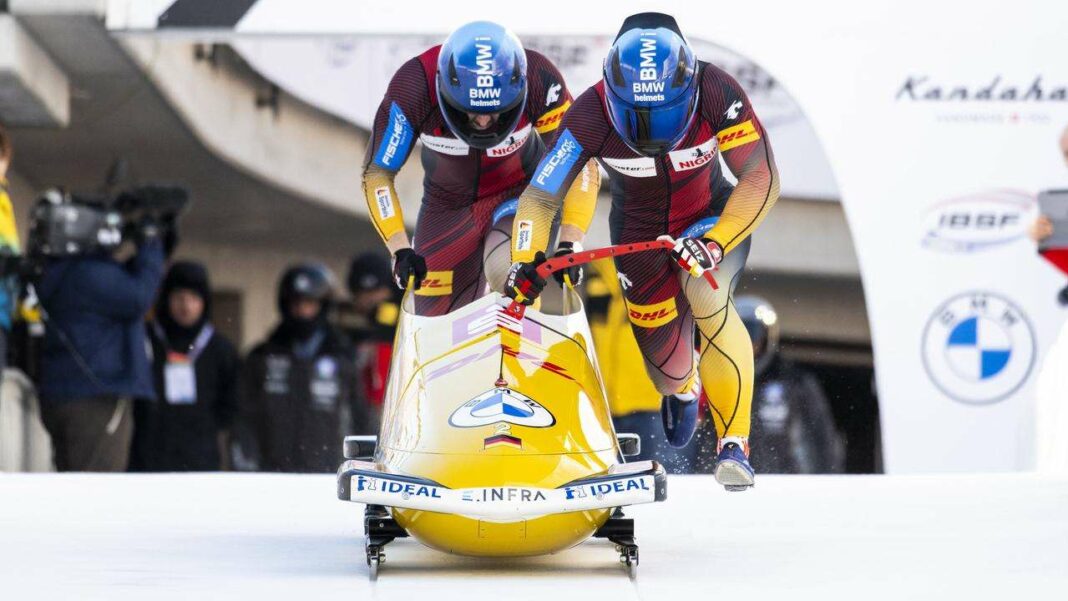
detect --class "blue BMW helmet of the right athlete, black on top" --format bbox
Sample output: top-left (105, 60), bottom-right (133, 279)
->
top-left (604, 13), bottom-right (697, 157)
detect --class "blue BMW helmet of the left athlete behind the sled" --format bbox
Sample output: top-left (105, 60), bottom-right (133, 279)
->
top-left (438, 21), bottom-right (527, 149)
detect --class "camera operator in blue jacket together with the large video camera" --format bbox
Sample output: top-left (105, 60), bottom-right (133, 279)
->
top-left (30, 187), bottom-right (176, 472)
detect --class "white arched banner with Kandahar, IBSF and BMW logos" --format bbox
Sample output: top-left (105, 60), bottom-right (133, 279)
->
top-left (101, 0), bottom-right (1068, 473)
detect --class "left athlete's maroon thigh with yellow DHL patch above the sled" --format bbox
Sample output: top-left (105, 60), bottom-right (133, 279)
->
top-left (414, 200), bottom-right (489, 315)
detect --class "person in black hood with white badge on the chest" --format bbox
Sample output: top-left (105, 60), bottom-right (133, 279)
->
top-left (130, 262), bottom-right (239, 472)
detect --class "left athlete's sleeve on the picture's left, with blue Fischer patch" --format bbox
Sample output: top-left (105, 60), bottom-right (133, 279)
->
top-left (363, 58), bottom-right (436, 241)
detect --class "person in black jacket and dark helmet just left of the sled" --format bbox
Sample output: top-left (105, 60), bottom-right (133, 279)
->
top-left (241, 264), bottom-right (368, 472)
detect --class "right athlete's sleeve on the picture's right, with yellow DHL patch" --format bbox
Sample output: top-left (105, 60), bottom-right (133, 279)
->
top-left (701, 65), bottom-right (779, 253)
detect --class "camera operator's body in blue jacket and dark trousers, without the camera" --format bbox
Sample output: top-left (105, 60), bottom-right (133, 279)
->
top-left (37, 228), bottom-right (163, 472)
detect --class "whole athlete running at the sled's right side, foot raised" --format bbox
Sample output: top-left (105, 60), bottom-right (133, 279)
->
top-left (505, 13), bottom-right (779, 491)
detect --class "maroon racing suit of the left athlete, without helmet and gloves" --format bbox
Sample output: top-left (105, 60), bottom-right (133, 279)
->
top-left (363, 46), bottom-right (598, 315)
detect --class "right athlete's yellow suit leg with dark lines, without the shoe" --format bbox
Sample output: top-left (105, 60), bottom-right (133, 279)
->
top-left (679, 235), bottom-right (753, 440)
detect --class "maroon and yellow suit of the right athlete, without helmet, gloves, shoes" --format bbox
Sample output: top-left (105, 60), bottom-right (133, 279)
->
top-left (513, 62), bottom-right (779, 437)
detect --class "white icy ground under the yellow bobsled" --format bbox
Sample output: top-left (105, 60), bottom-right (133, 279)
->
top-left (0, 474), bottom-right (1068, 601)
